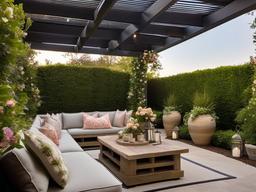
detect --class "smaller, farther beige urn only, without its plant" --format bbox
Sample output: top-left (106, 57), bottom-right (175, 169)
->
top-left (163, 111), bottom-right (181, 138)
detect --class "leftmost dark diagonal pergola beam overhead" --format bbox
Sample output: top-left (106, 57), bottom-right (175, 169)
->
top-left (76, 0), bottom-right (117, 51)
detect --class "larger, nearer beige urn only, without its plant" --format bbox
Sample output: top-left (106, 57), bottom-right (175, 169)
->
top-left (188, 115), bottom-right (216, 145)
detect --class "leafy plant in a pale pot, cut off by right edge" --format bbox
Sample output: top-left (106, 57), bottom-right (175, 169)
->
top-left (236, 62), bottom-right (256, 160)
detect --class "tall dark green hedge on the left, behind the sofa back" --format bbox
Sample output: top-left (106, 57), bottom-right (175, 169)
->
top-left (38, 65), bottom-right (129, 113)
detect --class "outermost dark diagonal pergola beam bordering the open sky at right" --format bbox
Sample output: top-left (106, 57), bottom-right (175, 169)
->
top-left (156, 0), bottom-right (256, 51)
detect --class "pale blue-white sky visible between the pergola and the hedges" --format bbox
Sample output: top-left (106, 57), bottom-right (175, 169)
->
top-left (36, 11), bottom-right (255, 77)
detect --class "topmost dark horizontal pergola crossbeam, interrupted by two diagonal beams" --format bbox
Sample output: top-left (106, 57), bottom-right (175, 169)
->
top-left (14, 0), bottom-right (202, 26)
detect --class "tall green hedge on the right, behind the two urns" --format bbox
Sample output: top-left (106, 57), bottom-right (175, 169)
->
top-left (148, 64), bottom-right (253, 129)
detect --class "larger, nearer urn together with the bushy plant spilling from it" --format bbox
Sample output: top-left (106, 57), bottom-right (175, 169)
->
top-left (185, 92), bottom-right (217, 145)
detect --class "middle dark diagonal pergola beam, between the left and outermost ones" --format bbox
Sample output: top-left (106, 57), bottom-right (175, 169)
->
top-left (109, 0), bottom-right (178, 51)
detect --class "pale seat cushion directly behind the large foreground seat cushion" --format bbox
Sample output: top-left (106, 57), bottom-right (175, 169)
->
top-left (59, 130), bottom-right (83, 153)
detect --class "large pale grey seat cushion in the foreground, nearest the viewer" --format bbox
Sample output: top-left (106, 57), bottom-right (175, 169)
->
top-left (48, 152), bottom-right (122, 192)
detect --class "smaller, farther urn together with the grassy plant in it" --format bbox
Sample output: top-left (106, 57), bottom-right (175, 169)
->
top-left (163, 94), bottom-right (181, 138)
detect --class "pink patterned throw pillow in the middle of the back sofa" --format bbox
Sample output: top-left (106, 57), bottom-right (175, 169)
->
top-left (83, 114), bottom-right (111, 129)
